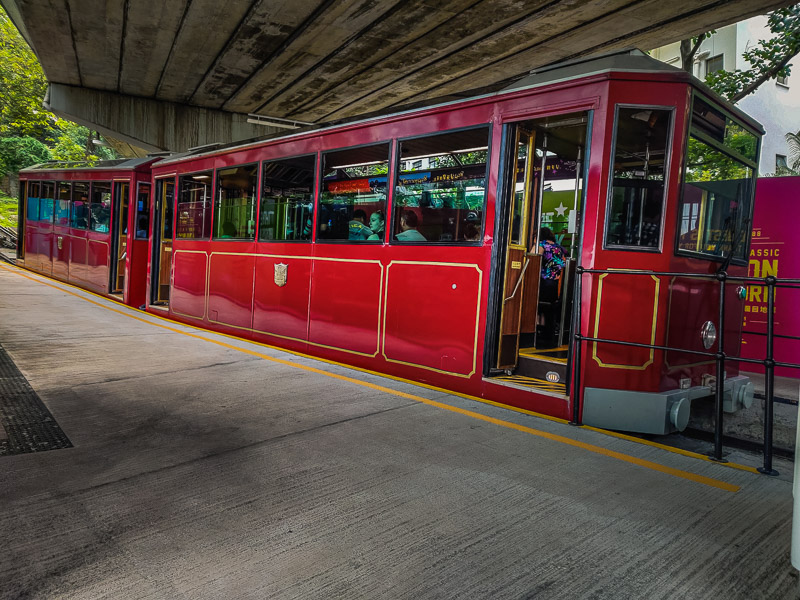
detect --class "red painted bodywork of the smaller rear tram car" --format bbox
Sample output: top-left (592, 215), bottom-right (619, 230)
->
top-left (20, 160), bottom-right (152, 307)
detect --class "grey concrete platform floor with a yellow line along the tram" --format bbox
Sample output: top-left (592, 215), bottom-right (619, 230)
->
top-left (0, 264), bottom-right (798, 599)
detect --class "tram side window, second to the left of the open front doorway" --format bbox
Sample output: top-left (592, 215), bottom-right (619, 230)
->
top-left (317, 143), bottom-right (389, 243)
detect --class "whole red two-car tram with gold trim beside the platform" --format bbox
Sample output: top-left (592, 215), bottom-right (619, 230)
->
top-left (15, 51), bottom-right (763, 433)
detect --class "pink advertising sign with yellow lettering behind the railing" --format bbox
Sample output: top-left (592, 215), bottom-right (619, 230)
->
top-left (741, 177), bottom-right (800, 378)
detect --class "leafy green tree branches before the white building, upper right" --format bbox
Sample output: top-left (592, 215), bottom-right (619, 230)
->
top-left (706, 4), bottom-right (800, 102)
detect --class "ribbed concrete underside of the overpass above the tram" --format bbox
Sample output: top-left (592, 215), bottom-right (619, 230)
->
top-left (0, 0), bottom-right (792, 151)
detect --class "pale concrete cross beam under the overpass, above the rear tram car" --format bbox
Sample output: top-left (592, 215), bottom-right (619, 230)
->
top-left (45, 83), bottom-right (285, 152)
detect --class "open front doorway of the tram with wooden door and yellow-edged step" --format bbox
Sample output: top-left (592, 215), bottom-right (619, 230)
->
top-left (493, 112), bottom-right (590, 394)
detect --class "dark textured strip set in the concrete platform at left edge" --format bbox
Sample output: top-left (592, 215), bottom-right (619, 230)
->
top-left (0, 345), bottom-right (72, 456)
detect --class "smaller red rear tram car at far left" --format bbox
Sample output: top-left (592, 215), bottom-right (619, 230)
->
top-left (18, 158), bottom-right (155, 306)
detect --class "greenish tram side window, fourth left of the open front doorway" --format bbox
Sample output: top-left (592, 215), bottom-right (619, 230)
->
top-left (214, 165), bottom-right (258, 240)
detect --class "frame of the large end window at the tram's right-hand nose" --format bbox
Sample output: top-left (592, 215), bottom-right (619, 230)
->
top-left (674, 90), bottom-right (764, 266)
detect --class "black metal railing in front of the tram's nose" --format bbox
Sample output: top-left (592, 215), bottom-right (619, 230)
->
top-left (572, 267), bottom-right (800, 475)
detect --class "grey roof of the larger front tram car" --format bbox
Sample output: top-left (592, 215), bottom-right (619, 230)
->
top-left (159, 48), bottom-right (764, 164)
